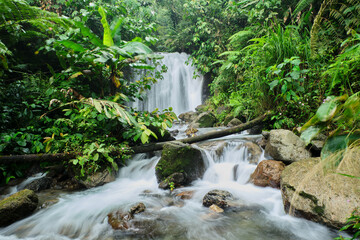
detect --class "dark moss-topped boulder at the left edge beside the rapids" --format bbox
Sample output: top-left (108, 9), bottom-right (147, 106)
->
top-left (0, 189), bottom-right (39, 227)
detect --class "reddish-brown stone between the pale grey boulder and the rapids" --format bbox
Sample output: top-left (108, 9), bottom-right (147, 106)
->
top-left (249, 160), bottom-right (285, 188)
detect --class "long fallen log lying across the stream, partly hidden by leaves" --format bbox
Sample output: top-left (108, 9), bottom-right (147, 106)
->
top-left (0, 112), bottom-right (270, 164)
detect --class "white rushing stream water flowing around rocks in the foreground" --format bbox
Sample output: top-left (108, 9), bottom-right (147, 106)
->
top-left (0, 135), bottom-right (334, 240)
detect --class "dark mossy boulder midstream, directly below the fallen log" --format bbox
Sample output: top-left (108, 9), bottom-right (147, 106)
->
top-left (155, 142), bottom-right (205, 185)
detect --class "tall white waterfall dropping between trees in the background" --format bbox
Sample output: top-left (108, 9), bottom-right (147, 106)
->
top-left (132, 53), bottom-right (203, 114)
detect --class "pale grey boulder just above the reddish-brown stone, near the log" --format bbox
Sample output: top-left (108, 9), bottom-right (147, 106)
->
top-left (265, 129), bottom-right (311, 163)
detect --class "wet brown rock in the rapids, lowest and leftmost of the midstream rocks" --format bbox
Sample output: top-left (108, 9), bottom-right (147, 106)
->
top-left (108, 203), bottom-right (146, 230)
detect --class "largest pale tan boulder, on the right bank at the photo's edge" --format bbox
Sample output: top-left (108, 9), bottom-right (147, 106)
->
top-left (281, 156), bottom-right (360, 228)
